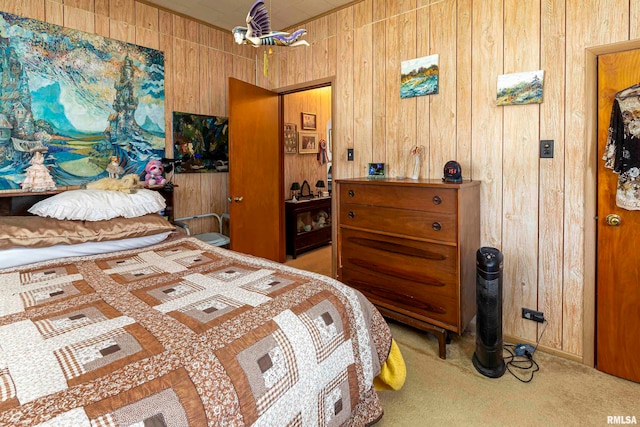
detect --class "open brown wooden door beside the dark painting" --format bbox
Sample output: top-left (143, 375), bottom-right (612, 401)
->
top-left (229, 78), bottom-right (286, 262)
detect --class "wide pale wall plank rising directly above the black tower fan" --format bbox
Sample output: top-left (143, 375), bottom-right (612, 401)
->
top-left (471, 0), bottom-right (503, 249)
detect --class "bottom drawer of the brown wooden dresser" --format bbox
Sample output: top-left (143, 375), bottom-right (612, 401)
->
top-left (339, 268), bottom-right (459, 332)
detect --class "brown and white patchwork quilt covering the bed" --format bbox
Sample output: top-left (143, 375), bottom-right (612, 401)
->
top-left (0, 237), bottom-right (391, 427)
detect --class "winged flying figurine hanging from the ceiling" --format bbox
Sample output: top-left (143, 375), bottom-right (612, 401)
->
top-left (232, 0), bottom-right (309, 47)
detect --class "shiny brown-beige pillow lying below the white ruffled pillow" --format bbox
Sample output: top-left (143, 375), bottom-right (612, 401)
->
top-left (0, 214), bottom-right (175, 249)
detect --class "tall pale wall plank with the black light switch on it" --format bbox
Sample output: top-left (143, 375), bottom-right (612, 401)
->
top-left (538, 0), bottom-right (565, 349)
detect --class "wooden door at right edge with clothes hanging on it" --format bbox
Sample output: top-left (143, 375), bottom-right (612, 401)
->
top-left (596, 50), bottom-right (640, 382)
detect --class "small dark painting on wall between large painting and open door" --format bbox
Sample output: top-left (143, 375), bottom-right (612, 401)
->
top-left (173, 112), bottom-right (229, 173)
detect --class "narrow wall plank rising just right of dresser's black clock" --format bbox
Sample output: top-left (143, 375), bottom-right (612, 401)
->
top-left (458, 0), bottom-right (474, 179)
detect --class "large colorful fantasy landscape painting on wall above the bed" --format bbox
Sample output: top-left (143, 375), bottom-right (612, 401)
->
top-left (0, 12), bottom-right (165, 190)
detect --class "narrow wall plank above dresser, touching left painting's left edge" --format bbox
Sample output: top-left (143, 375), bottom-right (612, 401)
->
top-left (384, 16), bottom-right (400, 176)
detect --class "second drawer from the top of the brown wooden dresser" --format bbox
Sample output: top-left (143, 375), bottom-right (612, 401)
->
top-left (340, 203), bottom-right (457, 243)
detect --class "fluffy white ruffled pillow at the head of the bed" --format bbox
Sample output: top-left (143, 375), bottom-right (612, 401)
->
top-left (29, 189), bottom-right (167, 221)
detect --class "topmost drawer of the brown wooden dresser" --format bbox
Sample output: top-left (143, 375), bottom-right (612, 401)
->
top-left (340, 183), bottom-right (457, 214)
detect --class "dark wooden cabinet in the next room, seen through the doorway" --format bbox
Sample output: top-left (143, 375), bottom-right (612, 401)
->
top-left (285, 197), bottom-right (331, 259)
